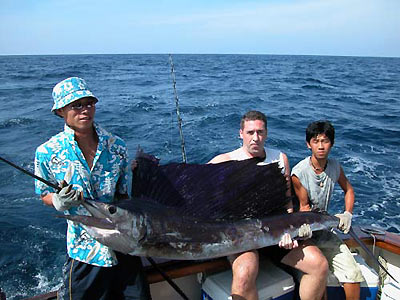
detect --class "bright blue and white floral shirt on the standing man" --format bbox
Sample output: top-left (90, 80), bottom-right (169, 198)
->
top-left (35, 123), bottom-right (128, 267)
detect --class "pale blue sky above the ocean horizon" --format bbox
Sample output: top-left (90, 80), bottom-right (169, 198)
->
top-left (0, 0), bottom-right (400, 57)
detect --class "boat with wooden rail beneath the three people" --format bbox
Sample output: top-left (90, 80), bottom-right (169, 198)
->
top-left (18, 226), bottom-right (400, 300)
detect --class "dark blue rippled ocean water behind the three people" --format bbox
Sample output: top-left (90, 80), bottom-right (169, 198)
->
top-left (0, 55), bottom-right (400, 299)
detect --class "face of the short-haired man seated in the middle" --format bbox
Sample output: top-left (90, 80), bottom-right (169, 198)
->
top-left (240, 120), bottom-right (267, 157)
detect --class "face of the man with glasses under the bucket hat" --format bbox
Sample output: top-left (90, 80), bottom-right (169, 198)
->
top-left (57, 97), bottom-right (96, 131)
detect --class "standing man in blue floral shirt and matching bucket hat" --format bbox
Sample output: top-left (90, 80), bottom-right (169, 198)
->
top-left (35, 77), bottom-right (150, 299)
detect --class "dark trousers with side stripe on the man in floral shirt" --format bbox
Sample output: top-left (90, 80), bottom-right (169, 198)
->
top-left (57, 253), bottom-right (151, 300)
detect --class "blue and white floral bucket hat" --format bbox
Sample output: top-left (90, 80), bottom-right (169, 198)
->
top-left (51, 77), bottom-right (98, 112)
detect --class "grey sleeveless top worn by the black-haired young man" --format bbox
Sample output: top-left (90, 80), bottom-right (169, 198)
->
top-left (292, 156), bottom-right (340, 211)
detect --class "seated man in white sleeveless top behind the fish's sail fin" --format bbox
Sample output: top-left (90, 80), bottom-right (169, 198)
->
top-left (209, 111), bottom-right (328, 300)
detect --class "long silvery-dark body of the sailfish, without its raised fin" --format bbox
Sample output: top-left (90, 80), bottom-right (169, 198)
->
top-left (62, 200), bottom-right (338, 260)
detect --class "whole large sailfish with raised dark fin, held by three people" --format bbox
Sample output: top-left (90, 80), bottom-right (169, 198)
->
top-left (62, 151), bottom-right (338, 260)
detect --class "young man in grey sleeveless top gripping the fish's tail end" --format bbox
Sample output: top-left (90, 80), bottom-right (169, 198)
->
top-left (292, 121), bottom-right (364, 300)
